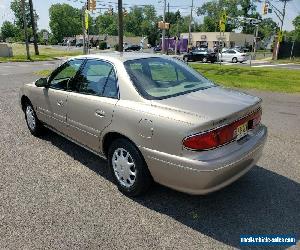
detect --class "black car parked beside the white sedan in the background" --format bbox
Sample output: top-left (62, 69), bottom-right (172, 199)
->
top-left (183, 48), bottom-right (218, 63)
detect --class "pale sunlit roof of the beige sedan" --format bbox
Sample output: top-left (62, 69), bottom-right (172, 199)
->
top-left (71, 52), bottom-right (170, 62)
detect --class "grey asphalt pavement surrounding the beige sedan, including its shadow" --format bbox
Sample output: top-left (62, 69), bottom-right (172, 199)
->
top-left (0, 62), bottom-right (300, 249)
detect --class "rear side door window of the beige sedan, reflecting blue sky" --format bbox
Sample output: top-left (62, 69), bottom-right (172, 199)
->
top-left (77, 60), bottom-right (118, 98)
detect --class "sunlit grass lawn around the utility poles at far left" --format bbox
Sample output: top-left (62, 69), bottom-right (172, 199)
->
top-left (0, 43), bottom-right (82, 62)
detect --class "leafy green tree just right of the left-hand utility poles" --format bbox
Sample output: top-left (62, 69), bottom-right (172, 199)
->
top-left (49, 4), bottom-right (82, 42)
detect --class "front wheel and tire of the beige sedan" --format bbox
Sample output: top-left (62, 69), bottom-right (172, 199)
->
top-left (24, 102), bottom-right (44, 136)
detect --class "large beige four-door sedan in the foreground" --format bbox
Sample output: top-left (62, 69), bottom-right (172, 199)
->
top-left (20, 53), bottom-right (267, 196)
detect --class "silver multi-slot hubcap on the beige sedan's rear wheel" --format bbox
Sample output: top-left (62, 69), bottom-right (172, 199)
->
top-left (112, 148), bottom-right (137, 187)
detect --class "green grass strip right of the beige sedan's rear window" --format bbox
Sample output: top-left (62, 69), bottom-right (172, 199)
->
top-left (190, 63), bottom-right (300, 93)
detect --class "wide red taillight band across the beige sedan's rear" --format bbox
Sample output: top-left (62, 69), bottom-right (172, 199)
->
top-left (183, 109), bottom-right (261, 150)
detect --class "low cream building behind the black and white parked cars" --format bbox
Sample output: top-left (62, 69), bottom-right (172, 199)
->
top-left (181, 32), bottom-right (254, 49)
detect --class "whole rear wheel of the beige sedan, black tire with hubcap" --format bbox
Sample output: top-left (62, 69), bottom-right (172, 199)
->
top-left (108, 139), bottom-right (152, 197)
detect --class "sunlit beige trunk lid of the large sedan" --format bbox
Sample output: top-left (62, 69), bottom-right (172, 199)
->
top-left (152, 87), bottom-right (261, 127)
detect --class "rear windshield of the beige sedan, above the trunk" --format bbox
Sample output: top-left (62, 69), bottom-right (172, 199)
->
top-left (124, 57), bottom-right (214, 99)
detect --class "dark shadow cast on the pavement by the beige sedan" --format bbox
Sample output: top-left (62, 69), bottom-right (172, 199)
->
top-left (43, 131), bottom-right (300, 248)
